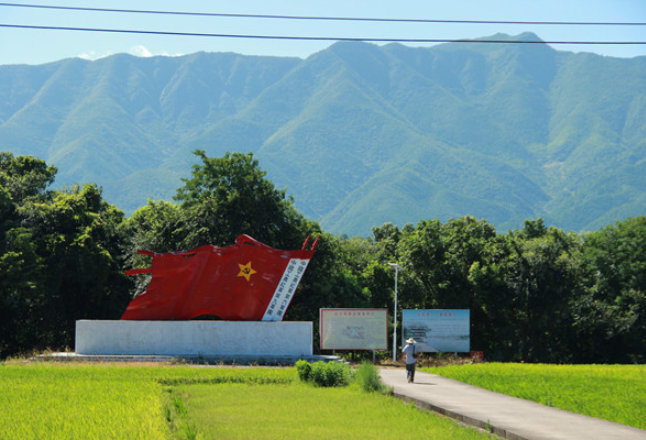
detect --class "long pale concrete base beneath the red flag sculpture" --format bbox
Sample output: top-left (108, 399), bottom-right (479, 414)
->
top-left (75, 320), bottom-right (320, 362)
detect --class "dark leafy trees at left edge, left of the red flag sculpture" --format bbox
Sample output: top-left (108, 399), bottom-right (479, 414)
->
top-left (0, 153), bottom-right (129, 356)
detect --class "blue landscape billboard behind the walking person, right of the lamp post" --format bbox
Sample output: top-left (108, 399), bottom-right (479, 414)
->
top-left (402, 309), bottom-right (471, 353)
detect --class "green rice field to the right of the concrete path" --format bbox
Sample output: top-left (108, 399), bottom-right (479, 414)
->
top-left (421, 363), bottom-right (646, 429)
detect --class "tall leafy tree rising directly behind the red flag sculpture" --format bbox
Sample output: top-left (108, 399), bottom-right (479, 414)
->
top-left (127, 151), bottom-right (330, 324)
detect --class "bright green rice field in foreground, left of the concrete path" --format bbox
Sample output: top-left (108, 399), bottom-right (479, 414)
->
top-left (0, 363), bottom-right (491, 440)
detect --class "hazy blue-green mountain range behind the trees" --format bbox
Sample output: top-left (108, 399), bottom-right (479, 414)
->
top-left (0, 33), bottom-right (646, 235)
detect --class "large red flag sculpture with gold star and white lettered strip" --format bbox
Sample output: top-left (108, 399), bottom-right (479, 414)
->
top-left (121, 235), bottom-right (318, 321)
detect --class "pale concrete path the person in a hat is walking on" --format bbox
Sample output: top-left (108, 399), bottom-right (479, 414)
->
top-left (379, 368), bottom-right (646, 440)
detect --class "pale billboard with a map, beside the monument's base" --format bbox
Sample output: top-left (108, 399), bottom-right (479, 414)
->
top-left (320, 309), bottom-right (388, 350)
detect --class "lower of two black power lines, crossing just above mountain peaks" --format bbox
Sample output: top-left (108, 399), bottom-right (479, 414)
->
top-left (0, 23), bottom-right (646, 45)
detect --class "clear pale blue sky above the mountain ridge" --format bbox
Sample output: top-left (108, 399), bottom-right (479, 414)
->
top-left (0, 0), bottom-right (646, 65)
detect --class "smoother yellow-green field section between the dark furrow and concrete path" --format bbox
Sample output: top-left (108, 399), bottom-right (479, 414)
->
top-left (173, 383), bottom-right (490, 440)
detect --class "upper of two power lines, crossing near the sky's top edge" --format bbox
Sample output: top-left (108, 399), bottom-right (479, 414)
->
top-left (0, 3), bottom-right (646, 26)
